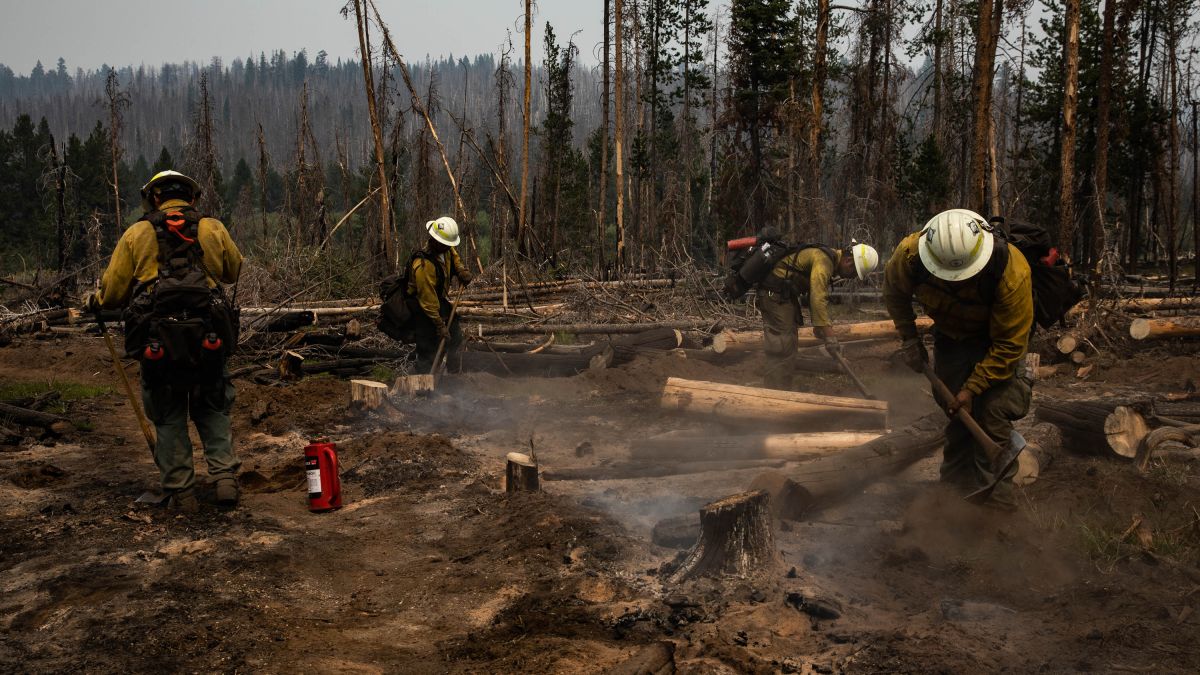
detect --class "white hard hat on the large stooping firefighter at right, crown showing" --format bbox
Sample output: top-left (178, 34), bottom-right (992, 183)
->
top-left (918, 209), bottom-right (992, 281)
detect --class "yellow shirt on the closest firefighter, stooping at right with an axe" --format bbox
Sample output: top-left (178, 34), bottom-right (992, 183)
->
top-left (883, 232), bottom-right (1033, 395)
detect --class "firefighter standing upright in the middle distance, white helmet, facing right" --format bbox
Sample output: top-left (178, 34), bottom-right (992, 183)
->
top-left (406, 216), bottom-right (473, 371)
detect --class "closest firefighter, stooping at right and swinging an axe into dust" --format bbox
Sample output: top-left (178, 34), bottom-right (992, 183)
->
top-left (883, 209), bottom-right (1033, 508)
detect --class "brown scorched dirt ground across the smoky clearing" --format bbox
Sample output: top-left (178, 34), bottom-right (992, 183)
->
top-left (0, 338), bottom-right (1200, 673)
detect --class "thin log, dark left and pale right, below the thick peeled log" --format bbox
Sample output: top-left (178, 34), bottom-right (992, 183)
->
top-left (630, 431), bottom-right (880, 461)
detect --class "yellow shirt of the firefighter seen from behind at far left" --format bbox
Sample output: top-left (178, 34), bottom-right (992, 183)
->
top-left (96, 199), bottom-right (242, 309)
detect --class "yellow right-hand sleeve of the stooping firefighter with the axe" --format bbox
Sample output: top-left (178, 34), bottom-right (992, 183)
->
top-left (964, 244), bottom-right (1033, 395)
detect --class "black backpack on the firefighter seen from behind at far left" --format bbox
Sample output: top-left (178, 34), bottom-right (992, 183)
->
top-left (124, 207), bottom-right (239, 384)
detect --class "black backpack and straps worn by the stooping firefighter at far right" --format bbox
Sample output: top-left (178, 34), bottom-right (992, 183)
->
top-left (912, 221), bottom-right (1084, 328)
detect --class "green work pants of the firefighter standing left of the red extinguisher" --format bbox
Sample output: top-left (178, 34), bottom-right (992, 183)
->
top-left (142, 376), bottom-right (241, 492)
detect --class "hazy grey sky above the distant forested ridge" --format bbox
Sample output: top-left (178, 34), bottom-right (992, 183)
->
top-left (0, 0), bottom-right (602, 74)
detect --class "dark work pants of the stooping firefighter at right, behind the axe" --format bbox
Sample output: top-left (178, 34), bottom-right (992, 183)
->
top-left (934, 335), bottom-right (1033, 504)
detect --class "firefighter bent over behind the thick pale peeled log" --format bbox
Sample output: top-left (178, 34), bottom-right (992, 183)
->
top-left (757, 244), bottom-right (880, 389)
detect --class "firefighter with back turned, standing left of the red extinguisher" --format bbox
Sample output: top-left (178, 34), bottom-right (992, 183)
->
top-left (84, 171), bottom-right (242, 513)
